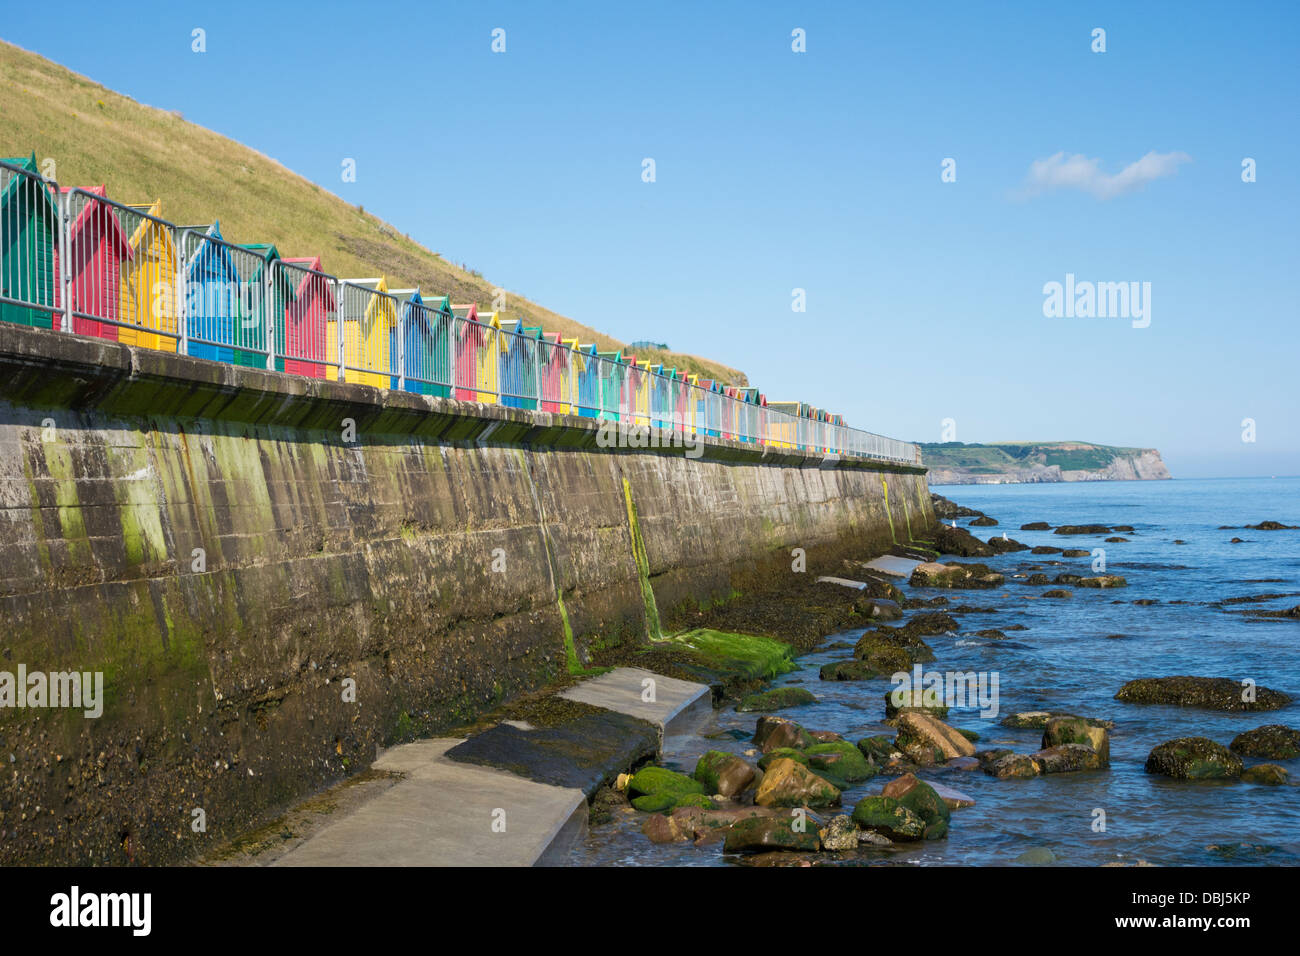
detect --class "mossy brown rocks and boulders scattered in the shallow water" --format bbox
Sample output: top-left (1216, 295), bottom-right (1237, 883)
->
top-left (593, 496), bottom-right (1300, 865)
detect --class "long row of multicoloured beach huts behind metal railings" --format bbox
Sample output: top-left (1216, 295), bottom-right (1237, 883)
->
top-left (0, 155), bottom-right (919, 463)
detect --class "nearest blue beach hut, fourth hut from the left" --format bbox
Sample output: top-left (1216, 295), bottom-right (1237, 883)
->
top-left (181, 221), bottom-right (243, 364)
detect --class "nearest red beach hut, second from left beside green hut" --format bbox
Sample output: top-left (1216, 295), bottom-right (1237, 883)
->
top-left (55, 186), bottom-right (131, 341)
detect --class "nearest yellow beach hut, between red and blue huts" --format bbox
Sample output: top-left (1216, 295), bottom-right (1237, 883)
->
top-left (117, 199), bottom-right (179, 352)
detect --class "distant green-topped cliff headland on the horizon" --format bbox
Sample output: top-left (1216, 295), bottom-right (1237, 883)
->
top-left (920, 441), bottom-right (1173, 485)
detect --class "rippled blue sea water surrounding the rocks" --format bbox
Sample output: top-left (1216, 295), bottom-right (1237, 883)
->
top-left (573, 479), bottom-right (1300, 866)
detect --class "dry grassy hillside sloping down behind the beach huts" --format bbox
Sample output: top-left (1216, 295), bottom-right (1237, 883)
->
top-left (0, 40), bottom-right (748, 385)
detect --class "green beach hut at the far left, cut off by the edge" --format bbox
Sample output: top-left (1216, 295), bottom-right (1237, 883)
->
top-left (0, 153), bottom-right (59, 329)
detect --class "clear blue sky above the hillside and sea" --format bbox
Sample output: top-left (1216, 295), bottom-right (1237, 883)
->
top-left (0, 0), bottom-right (1300, 477)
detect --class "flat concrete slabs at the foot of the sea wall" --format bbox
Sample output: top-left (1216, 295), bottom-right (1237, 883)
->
top-left (272, 667), bottom-right (712, 866)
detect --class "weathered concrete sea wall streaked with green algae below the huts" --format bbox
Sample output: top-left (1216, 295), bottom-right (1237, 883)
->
top-left (0, 324), bottom-right (932, 862)
